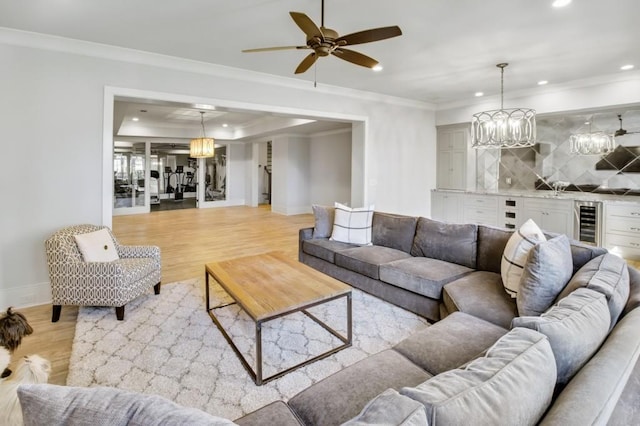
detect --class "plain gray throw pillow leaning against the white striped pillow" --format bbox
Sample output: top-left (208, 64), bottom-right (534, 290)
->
top-left (516, 235), bottom-right (573, 316)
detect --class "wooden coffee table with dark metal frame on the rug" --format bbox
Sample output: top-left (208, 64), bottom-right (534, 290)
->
top-left (205, 252), bottom-right (352, 385)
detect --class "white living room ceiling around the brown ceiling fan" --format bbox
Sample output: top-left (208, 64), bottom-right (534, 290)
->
top-left (0, 0), bottom-right (640, 104)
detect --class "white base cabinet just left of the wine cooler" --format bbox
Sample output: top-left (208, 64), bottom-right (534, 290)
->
top-left (522, 198), bottom-right (573, 238)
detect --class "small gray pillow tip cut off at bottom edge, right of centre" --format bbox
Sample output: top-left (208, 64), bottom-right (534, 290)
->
top-left (342, 389), bottom-right (428, 426)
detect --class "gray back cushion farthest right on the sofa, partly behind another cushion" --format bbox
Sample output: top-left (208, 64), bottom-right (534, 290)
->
top-left (558, 253), bottom-right (629, 328)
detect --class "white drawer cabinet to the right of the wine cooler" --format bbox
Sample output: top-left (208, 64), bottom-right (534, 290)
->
top-left (604, 203), bottom-right (640, 260)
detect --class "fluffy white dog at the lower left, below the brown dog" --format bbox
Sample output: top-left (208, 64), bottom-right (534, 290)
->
top-left (0, 349), bottom-right (51, 425)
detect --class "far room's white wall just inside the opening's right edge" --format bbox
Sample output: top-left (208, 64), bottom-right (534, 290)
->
top-left (309, 129), bottom-right (350, 207)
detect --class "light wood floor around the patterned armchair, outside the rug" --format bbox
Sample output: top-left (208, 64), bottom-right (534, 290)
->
top-left (8, 206), bottom-right (313, 385)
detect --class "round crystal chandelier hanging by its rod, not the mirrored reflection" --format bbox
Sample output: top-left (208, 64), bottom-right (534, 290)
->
top-left (471, 63), bottom-right (536, 148)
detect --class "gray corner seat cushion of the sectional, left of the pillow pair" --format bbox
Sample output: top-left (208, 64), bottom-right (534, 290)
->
top-left (442, 271), bottom-right (517, 330)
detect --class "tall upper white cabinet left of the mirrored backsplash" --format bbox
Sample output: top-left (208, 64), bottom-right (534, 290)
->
top-left (436, 126), bottom-right (469, 189)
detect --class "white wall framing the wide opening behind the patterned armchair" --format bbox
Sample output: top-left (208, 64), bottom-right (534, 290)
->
top-left (0, 28), bottom-right (435, 306)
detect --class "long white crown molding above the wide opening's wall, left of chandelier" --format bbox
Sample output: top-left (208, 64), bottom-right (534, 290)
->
top-left (0, 27), bottom-right (436, 111)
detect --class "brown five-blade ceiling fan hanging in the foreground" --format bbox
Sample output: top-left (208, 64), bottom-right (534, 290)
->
top-left (243, 0), bottom-right (402, 74)
